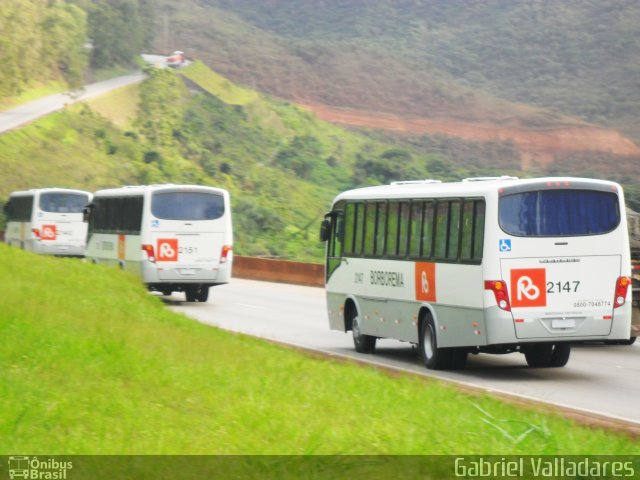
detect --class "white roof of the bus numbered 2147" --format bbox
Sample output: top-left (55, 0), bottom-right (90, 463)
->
top-left (334, 177), bottom-right (620, 203)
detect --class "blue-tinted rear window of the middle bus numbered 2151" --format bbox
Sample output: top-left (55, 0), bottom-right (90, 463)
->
top-left (151, 192), bottom-right (224, 220)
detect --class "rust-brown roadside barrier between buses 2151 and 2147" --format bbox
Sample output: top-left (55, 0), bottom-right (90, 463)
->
top-left (233, 255), bottom-right (324, 287)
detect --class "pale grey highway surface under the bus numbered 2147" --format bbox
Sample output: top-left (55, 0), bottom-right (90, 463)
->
top-left (166, 278), bottom-right (640, 434)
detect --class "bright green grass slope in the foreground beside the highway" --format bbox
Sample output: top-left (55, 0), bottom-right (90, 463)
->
top-left (0, 245), bottom-right (640, 455)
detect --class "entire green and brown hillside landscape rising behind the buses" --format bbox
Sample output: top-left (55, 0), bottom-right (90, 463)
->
top-left (0, 0), bottom-right (640, 259)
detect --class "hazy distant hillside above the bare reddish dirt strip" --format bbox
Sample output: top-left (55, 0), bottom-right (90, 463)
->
top-left (166, 0), bottom-right (640, 139)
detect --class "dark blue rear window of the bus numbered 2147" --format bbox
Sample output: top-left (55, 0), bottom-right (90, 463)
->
top-left (499, 189), bottom-right (620, 237)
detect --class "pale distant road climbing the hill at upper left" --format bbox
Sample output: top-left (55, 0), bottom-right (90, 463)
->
top-left (0, 72), bottom-right (146, 134)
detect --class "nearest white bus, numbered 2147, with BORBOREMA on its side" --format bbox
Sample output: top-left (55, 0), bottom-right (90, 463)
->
top-left (321, 177), bottom-right (631, 369)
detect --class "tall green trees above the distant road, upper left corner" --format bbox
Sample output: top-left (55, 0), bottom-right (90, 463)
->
top-left (0, 0), bottom-right (155, 100)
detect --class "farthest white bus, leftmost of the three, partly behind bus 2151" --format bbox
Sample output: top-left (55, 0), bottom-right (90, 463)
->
top-left (4, 188), bottom-right (91, 257)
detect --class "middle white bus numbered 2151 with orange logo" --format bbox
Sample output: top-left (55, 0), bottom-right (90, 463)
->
top-left (86, 185), bottom-right (233, 302)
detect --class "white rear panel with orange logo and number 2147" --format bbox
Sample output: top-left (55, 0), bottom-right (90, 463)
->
top-left (501, 255), bottom-right (621, 339)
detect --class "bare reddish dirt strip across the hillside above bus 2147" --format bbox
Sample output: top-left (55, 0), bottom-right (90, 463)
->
top-left (301, 103), bottom-right (640, 170)
